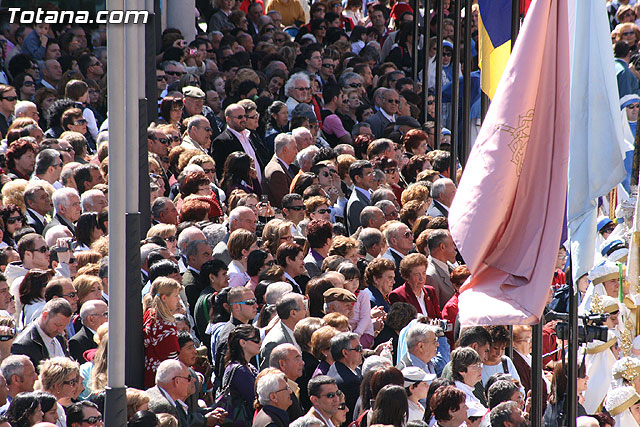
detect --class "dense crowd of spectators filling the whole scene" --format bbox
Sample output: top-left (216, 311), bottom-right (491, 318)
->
top-left (0, 0), bottom-right (640, 427)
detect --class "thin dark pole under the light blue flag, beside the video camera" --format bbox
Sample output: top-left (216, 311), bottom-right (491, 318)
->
top-left (560, 256), bottom-right (578, 427)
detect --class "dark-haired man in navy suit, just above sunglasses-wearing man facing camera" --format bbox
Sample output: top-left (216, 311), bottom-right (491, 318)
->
top-left (327, 332), bottom-right (362, 420)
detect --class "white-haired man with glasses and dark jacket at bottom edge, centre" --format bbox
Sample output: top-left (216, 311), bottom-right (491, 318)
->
top-left (253, 370), bottom-right (293, 427)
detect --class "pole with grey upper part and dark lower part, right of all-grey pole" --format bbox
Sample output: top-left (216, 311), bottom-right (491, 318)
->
top-left (125, 0), bottom-right (146, 387)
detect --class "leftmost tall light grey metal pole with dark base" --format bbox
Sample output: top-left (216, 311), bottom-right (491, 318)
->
top-left (105, 0), bottom-right (127, 427)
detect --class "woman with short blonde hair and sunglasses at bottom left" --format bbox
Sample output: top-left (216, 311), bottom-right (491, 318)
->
top-left (39, 357), bottom-right (82, 426)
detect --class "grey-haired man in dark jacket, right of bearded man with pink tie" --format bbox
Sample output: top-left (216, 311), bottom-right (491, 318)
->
top-left (262, 133), bottom-right (298, 208)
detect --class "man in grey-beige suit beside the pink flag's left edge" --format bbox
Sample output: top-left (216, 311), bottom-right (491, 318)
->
top-left (426, 230), bottom-right (458, 310)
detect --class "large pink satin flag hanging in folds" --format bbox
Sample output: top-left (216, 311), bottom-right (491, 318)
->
top-left (449, 0), bottom-right (570, 325)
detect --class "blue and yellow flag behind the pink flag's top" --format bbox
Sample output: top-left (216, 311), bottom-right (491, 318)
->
top-left (478, 0), bottom-right (512, 98)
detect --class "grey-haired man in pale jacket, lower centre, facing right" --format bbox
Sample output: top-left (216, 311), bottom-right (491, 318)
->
top-left (259, 292), bottom-right (308, 375)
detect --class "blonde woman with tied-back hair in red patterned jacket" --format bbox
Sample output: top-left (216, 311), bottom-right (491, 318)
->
top-left (143, 277), bottom-right (182, 388)
